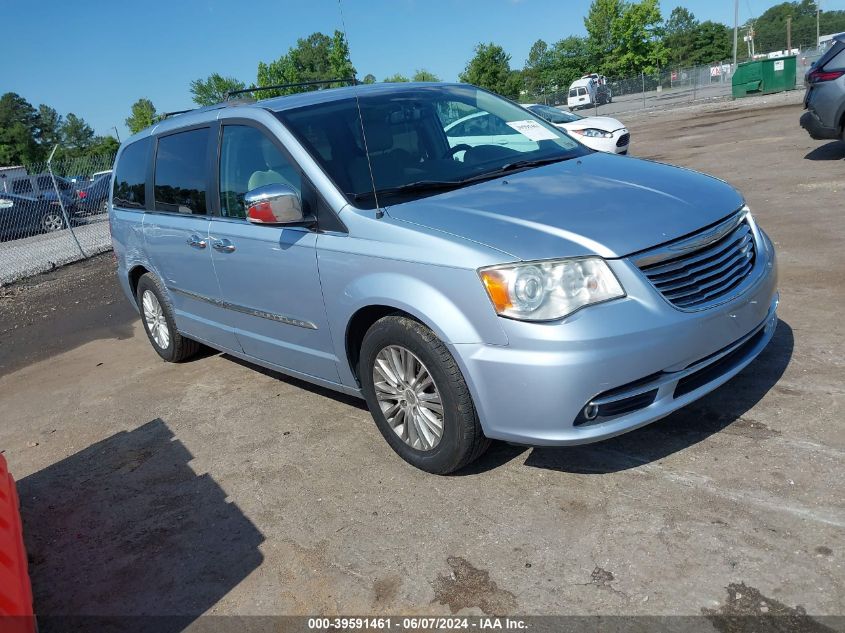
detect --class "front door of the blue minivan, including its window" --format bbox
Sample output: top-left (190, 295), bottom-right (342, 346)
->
top-left (209, 124), bottom-right (339, 383)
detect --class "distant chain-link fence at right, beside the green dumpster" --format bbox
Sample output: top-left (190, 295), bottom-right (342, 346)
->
top-left (520, 49), bottom-right (822, 115)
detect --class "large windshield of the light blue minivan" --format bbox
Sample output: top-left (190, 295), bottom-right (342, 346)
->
top-left (277, 85), bottom-right (589, 208)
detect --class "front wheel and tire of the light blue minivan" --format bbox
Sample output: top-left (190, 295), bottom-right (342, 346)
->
top-left (358, 315), bottom-right (490, 475)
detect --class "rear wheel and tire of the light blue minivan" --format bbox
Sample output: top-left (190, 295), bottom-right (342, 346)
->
top-left (135, 273), bottom-right (200, 363)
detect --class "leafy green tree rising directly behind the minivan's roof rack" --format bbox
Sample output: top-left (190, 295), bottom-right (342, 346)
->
top-left (258, 31), bottom-right (356, 97)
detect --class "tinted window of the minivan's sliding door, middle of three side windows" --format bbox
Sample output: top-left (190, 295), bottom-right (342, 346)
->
top-left (155, 128), bottom-right (209, 215)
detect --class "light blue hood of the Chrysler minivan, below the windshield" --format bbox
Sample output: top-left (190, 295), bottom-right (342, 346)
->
top-left (387, 152), bottom-right (743, 260)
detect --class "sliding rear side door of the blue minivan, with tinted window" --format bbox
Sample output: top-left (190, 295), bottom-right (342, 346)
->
top-left (144, 128), bottom-right (240, 351)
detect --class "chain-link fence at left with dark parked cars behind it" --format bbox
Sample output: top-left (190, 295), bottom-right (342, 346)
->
top-left (0, 151), bottom-right (114, 286)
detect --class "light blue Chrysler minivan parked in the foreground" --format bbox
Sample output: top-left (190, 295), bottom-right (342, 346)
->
top-left (109, 83), bottom-right (778, 473)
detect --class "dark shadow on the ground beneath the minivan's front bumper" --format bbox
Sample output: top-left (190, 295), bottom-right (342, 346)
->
top-left (455, 320), bottom-right (794, 476)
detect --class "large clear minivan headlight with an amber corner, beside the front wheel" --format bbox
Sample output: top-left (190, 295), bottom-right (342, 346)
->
top-left (478, 257), bottom-right (625, 321)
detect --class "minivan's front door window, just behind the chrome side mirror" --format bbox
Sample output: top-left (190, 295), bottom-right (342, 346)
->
top-left (220, 125), bottom-right (302, 218)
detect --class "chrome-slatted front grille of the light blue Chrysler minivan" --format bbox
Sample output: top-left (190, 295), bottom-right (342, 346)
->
top-left (640, 218), bottom-right (756, 310)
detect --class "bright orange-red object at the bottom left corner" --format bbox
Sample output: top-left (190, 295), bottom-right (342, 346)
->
top-left (0, 455), bottom-right (35, 633)
